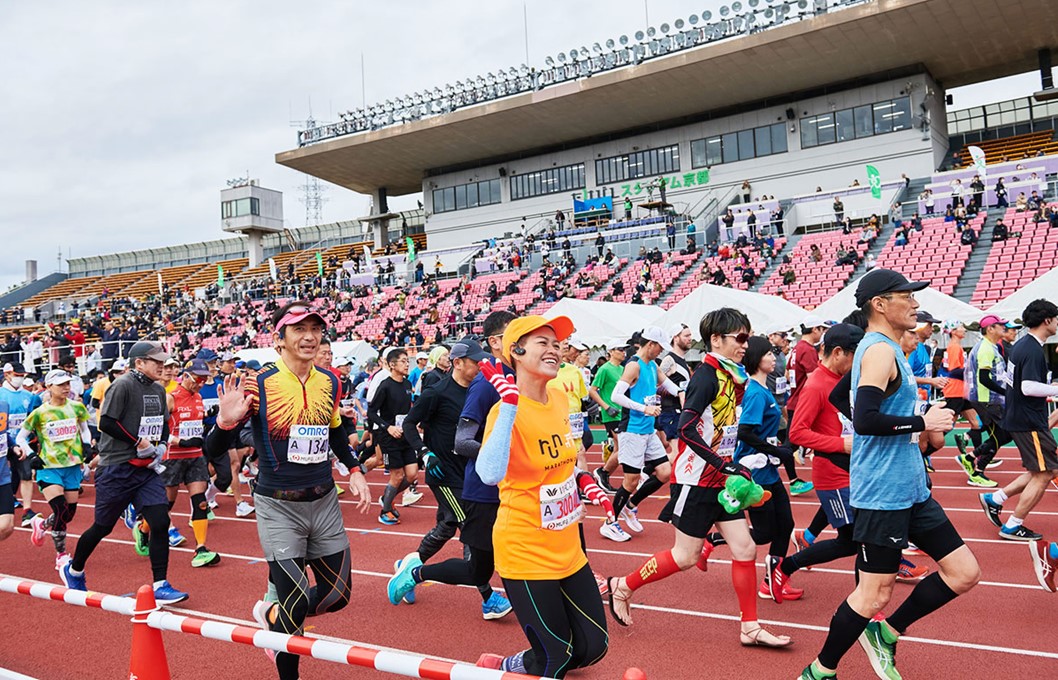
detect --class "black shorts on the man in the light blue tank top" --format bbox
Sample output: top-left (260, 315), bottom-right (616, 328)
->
top-left (853, 496), bottom-right (963, 574)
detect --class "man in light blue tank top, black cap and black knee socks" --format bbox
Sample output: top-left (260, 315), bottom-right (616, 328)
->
top-left (800, 269), bottom-right (981, 680)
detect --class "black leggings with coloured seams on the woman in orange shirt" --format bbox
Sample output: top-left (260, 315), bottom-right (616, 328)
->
top-left (504, 565), bottom-right (609, 678)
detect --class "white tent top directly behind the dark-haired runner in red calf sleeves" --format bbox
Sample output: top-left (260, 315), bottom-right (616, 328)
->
top-left (655, 283), bottom-right (808, 336)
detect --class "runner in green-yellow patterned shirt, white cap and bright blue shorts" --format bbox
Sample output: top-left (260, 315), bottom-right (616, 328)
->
top-left (17, 370), bottom-right (93, 570)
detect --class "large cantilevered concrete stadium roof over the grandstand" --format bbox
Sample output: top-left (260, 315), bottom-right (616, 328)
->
top-left (276, 0), bottom-right (1058, 196)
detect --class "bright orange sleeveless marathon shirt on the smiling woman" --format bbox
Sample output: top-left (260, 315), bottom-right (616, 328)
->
top-left (482, 387), bottom-right (587, 581)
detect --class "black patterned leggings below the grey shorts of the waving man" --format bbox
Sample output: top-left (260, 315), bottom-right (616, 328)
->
top-left (268, 548), bottom-right (351, 680)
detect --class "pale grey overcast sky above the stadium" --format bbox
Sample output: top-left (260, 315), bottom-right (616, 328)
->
top-left (0, 0), bottom-right (1039, 291)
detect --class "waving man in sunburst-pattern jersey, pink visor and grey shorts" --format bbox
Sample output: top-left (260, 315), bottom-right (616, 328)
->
top-left (205, 300), bottom-right (371, 680)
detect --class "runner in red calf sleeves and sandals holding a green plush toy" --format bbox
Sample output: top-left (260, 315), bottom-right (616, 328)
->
top-left (609, 307), bottom-right (790, 647)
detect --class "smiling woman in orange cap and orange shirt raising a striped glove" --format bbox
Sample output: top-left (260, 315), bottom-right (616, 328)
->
top-left (477, 316), bottom-right (609, 678)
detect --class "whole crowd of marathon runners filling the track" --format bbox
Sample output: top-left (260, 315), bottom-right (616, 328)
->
top-left (0, 269), bottom-right (1058, 680)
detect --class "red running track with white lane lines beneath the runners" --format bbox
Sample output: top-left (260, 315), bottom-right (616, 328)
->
top-left (0, 447), bottom-right (1058, 680)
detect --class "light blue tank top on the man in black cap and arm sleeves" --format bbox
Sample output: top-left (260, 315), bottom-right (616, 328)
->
top-left (849, 332), bottom-right (929, 510)
